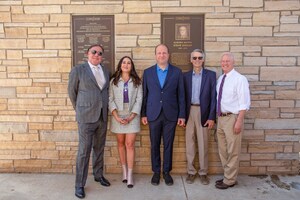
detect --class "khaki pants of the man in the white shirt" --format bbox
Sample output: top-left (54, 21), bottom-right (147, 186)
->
top-left (217, 114), bottom-right (244, 185)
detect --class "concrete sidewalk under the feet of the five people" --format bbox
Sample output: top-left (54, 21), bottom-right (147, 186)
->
top-left (0, 173), bottom-right (300, 200)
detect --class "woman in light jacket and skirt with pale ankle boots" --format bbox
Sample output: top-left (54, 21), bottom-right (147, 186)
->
top-left (109, 56), bottom-right (143, 188)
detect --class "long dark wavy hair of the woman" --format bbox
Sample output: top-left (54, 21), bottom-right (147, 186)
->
top-left (111, 56), bottom-right (142, 87)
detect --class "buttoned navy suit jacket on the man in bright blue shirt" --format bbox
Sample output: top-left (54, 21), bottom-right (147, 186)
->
top-left (141, 64), bottom-right (185, 121)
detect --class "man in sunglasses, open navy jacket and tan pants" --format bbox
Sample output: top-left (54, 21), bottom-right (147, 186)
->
top-left (184, 49), bottom-right (217, 185)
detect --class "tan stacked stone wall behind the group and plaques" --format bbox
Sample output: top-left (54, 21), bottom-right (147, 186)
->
top-left (0, 0), bottom-right (300, 174)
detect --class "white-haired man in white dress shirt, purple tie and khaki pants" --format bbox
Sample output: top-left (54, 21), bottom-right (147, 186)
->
top-left (215, 52), bottom-right (250, 189)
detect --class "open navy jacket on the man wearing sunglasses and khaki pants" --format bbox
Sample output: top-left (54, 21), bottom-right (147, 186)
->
top-left (183, 69), bottom-right (217, 126)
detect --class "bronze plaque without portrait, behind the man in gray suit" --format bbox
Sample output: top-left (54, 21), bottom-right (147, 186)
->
top-left (72, 15), bottom-right (115, 73)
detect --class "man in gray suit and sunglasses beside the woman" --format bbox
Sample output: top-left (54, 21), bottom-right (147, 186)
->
top-left (68, 44), bottom-right (110, 198)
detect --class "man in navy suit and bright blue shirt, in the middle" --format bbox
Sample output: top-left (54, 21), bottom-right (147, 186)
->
top-left (142, 44), bottom-right (185, 185)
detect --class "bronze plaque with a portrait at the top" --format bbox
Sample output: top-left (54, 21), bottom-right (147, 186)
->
top-left (161, 14), bottom-right (204, 71)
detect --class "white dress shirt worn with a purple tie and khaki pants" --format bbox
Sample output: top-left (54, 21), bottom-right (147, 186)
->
top-left (217, 69), bottom-right (250, 114)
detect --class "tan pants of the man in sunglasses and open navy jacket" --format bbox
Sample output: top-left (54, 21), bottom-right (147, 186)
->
top-left (185, 106), bottom-right (208, 175)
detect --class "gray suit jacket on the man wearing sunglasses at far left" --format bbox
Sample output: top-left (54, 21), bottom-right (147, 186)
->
top-left (68, 62), bottom-right (109, 123)
